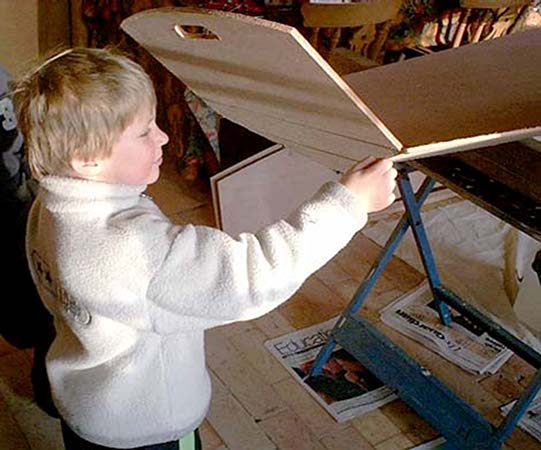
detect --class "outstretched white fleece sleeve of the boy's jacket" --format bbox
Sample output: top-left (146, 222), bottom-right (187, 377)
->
top-left (143, 182), bottom-right (366, 333)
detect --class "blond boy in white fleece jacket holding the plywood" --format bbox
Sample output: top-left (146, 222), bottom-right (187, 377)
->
top-left (15, 49), bottom-right (396, 449)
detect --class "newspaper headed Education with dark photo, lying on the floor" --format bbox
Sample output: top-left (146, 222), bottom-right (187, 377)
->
top-left (265, 317), bottom-right (398, 422)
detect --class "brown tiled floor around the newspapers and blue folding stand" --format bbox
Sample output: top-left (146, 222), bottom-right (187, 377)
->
top-left (0, 153), bottom-right (541, 450)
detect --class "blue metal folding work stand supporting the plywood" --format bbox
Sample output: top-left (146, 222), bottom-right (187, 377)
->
top-left (311, 164), bottom-right (541, 450)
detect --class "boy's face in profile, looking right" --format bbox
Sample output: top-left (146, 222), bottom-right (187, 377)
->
top-left (95, 108), bottom-right (169, 185)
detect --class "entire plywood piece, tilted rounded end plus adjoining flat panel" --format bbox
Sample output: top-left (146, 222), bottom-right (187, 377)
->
top-left (121, 8), bottom-right (541, 166)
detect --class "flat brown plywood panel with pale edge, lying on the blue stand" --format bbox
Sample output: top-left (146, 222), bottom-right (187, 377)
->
top-left (345, 29), bottom-right (541, 153)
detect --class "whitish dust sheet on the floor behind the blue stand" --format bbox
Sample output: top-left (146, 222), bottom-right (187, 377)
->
top-left (363, 200), bottom-right (541, 348)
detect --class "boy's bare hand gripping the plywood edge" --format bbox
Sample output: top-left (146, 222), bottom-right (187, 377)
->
top-left (340, 157), bottom-right (398, 213)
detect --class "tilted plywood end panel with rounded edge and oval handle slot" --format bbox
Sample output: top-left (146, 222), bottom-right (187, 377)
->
top-left (121, 8), bottom-right (395, 171)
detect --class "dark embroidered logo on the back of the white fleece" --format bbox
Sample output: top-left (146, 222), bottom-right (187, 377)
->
top-left (32, 250), bottom-right (92, 325)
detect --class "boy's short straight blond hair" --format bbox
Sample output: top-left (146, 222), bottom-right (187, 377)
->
top-left (13, 48), bottom-right (156, 179)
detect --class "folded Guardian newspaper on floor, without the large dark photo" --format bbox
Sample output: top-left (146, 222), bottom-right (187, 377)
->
top-left (380, 282), bottom-right (513, 374)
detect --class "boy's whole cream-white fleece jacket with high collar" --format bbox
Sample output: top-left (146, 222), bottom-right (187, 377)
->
top-left (27, 177), bottom-right (366, 448)
